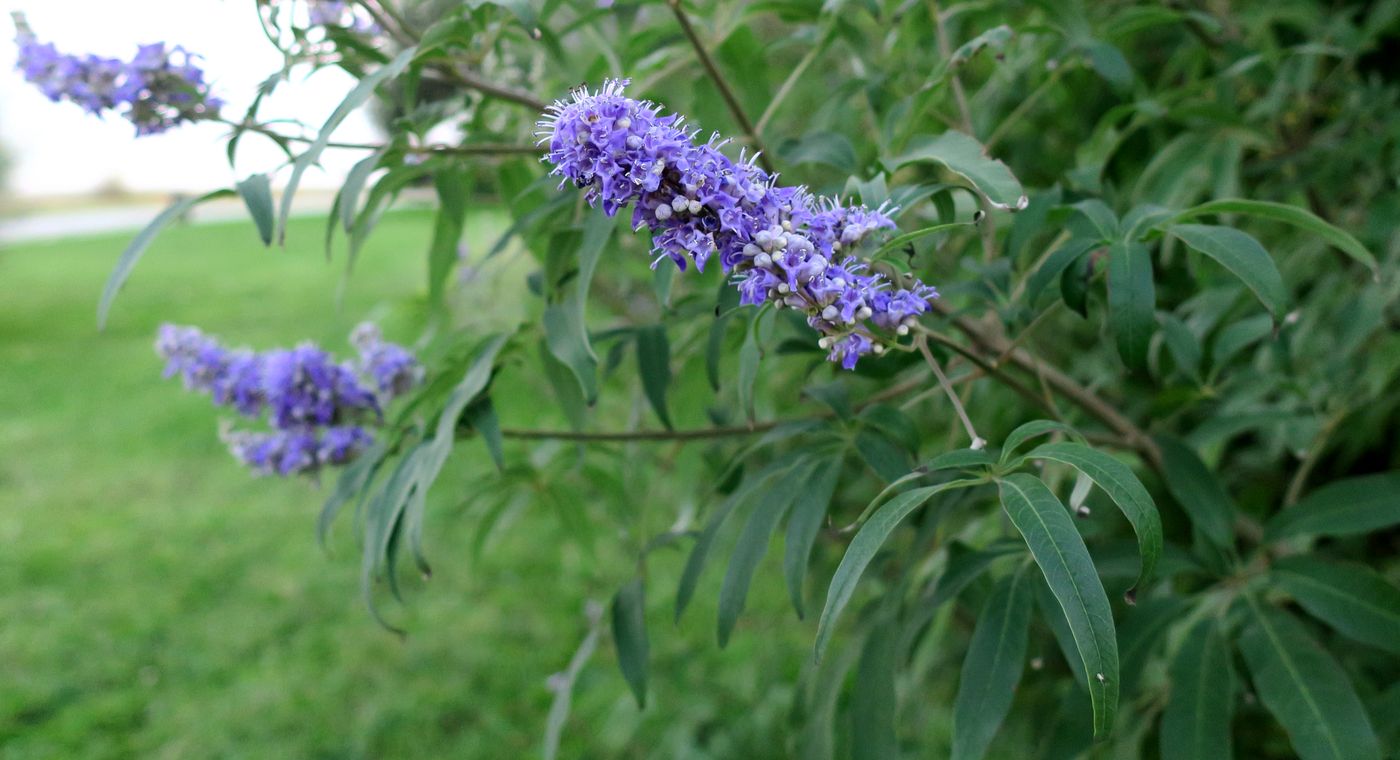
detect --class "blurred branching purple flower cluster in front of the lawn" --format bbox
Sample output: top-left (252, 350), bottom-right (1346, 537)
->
top-left (155, 323), bottom-right (423, 476)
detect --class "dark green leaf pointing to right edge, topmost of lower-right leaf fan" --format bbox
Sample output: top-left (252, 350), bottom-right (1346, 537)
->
top-left (1264, 470), bottom-right (1400, 542)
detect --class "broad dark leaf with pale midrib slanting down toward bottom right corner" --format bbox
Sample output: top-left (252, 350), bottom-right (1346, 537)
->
top-left (1239, 598), bottom-right (1380, 760)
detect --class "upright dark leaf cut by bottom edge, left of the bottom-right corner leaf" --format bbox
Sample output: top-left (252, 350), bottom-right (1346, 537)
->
top-left (1162, 620), bottom-right (1235, 760)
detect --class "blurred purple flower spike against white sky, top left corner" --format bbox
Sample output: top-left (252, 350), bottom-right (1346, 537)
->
top-left (15, 15), bottom-right (223, 136)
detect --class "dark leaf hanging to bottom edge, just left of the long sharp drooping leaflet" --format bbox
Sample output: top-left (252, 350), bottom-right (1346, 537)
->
top-left (952, 565), bottom-right (1032, 760)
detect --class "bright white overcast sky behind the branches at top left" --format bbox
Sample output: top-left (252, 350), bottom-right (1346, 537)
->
top-left (0, 0), bottom-right (377, 196)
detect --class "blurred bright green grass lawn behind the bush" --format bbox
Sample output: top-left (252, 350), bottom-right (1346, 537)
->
top-left (0, 211), bottom-right (811, 759)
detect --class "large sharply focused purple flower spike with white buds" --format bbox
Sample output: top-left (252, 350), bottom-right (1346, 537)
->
top-left (536, 80), bottom-right (938, 370)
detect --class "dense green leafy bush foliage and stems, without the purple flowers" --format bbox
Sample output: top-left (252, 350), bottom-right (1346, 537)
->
top-left (60, 0), bottom-right (1400, 760)
